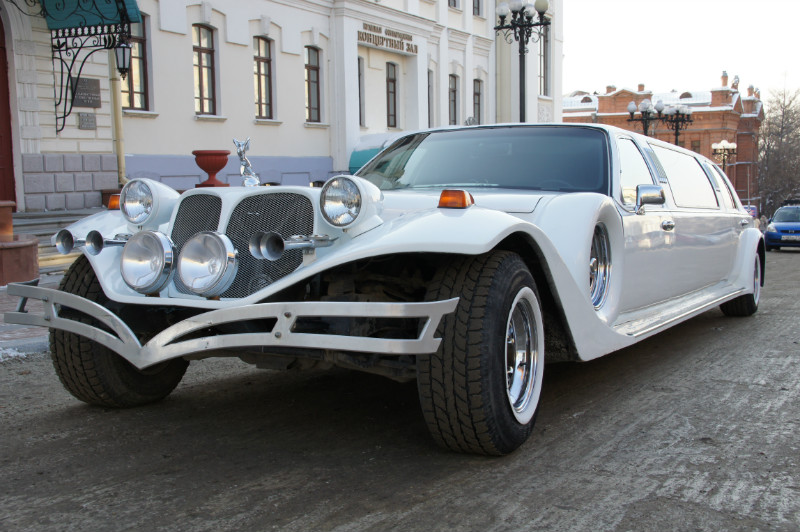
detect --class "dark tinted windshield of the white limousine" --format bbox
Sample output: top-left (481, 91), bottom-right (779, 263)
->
top-left (356, 126), bottom-right (608, 194)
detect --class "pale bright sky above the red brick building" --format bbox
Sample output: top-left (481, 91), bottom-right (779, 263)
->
top-left (562, 0), bottom-right (800, 106)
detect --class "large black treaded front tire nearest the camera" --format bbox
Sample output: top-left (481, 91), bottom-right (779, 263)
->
top-left (417, 251), bottom-right (544, 455)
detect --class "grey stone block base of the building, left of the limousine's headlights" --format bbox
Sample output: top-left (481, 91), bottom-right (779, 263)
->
top-left (22, 153), bottom-right (119, 212)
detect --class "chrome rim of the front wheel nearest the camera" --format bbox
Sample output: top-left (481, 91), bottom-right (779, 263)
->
top-left (505, 288), bottom-right (542, 424)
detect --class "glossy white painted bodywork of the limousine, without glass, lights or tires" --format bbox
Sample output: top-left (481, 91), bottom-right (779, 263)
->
top-left (6, 126), bottom-right (763, 367)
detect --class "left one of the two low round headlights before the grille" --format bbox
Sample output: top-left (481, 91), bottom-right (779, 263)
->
top-left (120, 231), bottom-right (175, 294)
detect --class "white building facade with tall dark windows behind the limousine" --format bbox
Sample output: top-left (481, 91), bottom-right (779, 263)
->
top-left (0, 0), bottom-right (562, 211)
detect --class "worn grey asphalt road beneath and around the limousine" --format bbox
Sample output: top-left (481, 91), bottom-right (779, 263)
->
top-left (0, 250), bottom-right (800, 531)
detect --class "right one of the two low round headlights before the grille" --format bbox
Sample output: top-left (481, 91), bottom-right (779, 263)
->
top-left (178, 231), bottom-right (239, 297)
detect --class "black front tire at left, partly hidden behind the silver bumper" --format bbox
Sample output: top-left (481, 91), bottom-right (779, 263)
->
top-left (50, 255), bottom-right (189, 408)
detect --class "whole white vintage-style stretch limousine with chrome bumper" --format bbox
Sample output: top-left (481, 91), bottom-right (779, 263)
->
top-left (6, 124), bottom-right (764, 455)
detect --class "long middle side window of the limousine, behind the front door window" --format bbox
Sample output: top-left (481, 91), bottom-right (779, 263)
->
top-left (651, 145), bottom-right (719, 209)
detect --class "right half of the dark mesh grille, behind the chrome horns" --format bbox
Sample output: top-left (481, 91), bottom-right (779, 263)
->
top-left (222, 192), bottom-right (314, 298)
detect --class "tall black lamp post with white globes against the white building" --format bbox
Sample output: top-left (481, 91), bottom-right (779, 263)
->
top-left (494, 0), bottom-right (550, 122)
